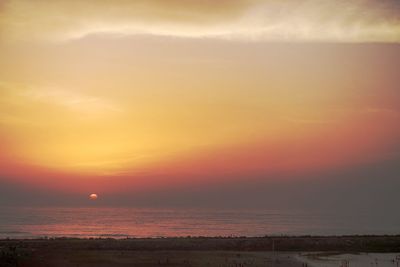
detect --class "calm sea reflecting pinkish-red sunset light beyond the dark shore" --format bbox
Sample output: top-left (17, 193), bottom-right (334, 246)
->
top-left (0, 207), bottom-right (400, 241)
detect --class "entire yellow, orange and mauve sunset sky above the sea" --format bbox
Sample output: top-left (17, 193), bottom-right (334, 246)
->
top-left (0, 0), bottom-right (400, 209)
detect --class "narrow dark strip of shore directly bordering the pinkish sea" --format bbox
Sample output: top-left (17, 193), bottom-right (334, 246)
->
top-left (0, 235), bottom-right (400, 252)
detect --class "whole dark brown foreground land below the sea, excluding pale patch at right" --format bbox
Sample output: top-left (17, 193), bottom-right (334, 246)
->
top-left (0, 238), bottom-right (400, 267)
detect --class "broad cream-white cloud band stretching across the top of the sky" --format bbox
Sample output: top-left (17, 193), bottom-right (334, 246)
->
top-left (0, 0), bottom-right (400, 43)
